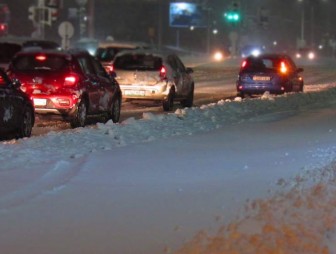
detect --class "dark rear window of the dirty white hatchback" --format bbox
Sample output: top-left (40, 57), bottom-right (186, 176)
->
top-left (113, 54), bottom-right (162, 71)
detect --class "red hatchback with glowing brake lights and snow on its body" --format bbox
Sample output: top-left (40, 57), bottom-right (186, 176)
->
top-left (8, 50), bottom-right (121, 127)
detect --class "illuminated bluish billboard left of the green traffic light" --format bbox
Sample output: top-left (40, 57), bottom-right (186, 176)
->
top-left (169, 2), bottom-right (207, 27)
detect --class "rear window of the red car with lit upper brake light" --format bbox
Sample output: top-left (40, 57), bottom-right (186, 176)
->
top-left (13, 54), bottom-right (67, 71)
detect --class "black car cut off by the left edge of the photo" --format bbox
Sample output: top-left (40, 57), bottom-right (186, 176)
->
top-left (0, 69), bottom-right (35, 139)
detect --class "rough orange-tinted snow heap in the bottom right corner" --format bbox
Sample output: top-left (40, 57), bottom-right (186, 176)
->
top-left (176, 163), bottom-right (336, 254)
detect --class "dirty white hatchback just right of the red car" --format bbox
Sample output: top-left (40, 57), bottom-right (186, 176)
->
top-left (113, 50), bottom-right (194, 111)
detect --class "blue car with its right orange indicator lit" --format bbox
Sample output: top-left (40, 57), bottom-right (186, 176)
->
top-left (236, 54), bottom-right (303, 97)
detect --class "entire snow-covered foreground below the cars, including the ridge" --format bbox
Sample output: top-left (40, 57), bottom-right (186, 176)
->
top-left (0, 62), bottom-right (336, 254)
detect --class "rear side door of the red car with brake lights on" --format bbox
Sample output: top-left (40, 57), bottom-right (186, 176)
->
top-left (78, 55), bottom-right (100, 114)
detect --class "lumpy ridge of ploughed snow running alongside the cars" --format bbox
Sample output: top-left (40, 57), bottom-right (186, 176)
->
top-left (0, 88), bottom-right (336, 170)
